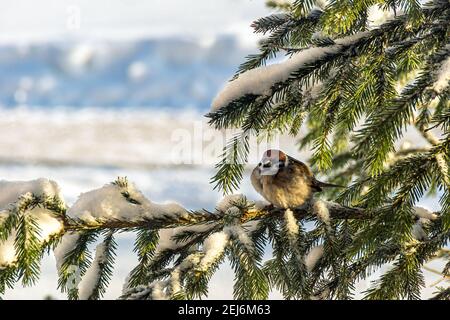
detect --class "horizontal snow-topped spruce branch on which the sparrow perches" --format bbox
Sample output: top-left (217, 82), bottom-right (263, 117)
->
top-left (0, 178), bottom-right (440, 241)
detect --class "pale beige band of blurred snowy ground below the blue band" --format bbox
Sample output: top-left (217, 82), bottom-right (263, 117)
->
top-left (0, 107), bottom-right (306, 169)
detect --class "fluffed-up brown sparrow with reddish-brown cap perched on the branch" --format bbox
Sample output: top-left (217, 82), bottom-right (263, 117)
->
top-left (251, 150), bottom-right (340, 209)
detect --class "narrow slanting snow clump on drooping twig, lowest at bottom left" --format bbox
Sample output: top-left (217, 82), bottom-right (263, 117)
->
top-left (78, 243), bottom-right (106, 300)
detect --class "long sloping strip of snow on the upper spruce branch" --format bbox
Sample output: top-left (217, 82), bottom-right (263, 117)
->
top-left (211, 32), bottom-right (369, 111)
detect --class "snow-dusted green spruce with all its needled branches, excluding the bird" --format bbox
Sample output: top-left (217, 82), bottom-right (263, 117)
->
top-left (0, 0), bottom-right (450, 300)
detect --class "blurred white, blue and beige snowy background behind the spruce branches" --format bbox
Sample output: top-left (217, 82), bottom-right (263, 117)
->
top-left (0, 0), bottom-right (439, 299)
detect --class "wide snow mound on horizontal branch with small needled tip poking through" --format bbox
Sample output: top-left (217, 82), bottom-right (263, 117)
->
top-left (67, 183), bottom-right (189, 223)
